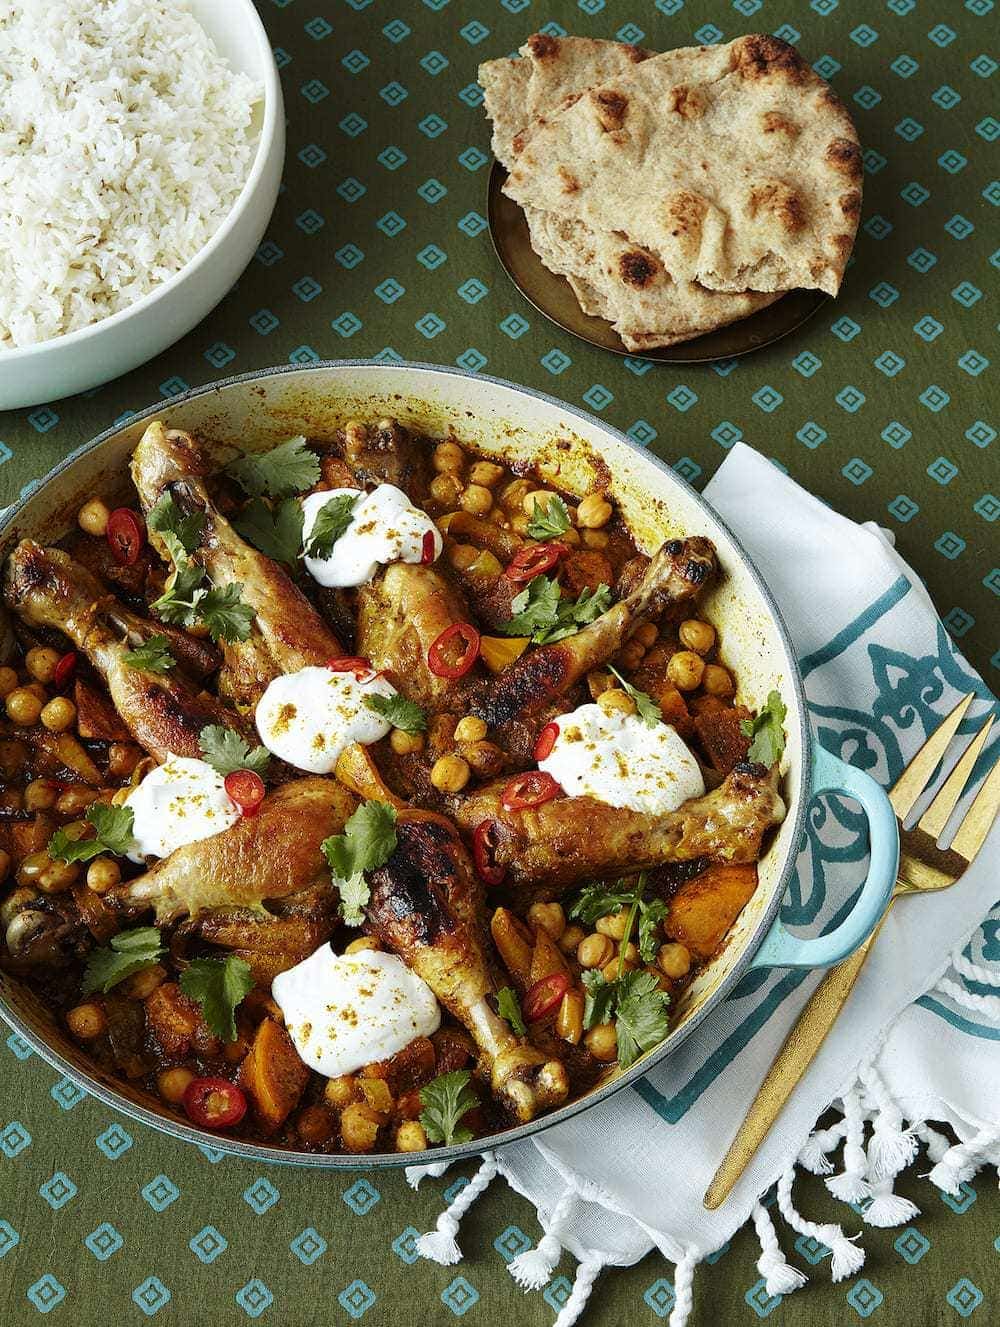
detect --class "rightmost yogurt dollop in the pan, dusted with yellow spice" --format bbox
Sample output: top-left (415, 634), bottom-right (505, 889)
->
top-left (538, 705), bottom-right (704, 815)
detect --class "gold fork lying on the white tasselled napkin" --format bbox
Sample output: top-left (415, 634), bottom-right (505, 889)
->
top-left (704, 691), bottom-right (1000, 1212)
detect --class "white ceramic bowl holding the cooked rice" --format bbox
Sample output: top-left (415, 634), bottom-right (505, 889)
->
top-left (0, 0), bottom-right (285, 410)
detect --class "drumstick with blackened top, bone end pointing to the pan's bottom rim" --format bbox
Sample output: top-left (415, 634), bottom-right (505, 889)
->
top-left (366, 812), bottom-right (569, 1121)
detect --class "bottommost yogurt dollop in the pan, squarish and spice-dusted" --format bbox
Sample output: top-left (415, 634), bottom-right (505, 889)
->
top-left (271, 945), bottom-right (440, 1078)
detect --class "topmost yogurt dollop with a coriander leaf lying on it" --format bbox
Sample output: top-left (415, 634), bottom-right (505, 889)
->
top-left (302, 484), bottom-right (443, 588)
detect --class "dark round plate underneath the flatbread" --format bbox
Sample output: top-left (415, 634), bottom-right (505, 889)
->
top-left (487, 162), bottom-right (830, 364)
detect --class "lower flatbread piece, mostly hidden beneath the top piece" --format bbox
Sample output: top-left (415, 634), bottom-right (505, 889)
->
top-left (479, 33), bottom-right (779, 350)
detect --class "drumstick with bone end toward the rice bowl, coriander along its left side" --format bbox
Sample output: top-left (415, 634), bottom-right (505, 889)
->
top-left (131, 419), bottom-right (344, 703)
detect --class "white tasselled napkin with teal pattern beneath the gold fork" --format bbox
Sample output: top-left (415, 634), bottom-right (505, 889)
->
top-left (410, 443), bottom-right (1000, 1327)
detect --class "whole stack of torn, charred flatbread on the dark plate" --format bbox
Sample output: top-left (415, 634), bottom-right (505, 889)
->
top-left (479, 33), bottom-right (861, 350)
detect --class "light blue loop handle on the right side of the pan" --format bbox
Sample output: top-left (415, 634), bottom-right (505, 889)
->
top-left (749, 744), bottom-right (899, 967)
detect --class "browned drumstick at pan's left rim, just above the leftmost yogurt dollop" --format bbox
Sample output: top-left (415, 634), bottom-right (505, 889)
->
top-left (4, 539), bottom-right (252, 760)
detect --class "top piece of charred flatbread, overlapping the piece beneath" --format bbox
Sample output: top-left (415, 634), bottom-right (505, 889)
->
top-left (504, 35), bottom-right (861, 295)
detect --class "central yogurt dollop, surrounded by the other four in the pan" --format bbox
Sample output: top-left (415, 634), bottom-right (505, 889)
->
top-left (255, 666), bottom-right (397, 774)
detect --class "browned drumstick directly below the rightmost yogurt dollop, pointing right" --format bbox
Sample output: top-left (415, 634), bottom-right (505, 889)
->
top-left (455, 764), bottom-right (785, 901)
